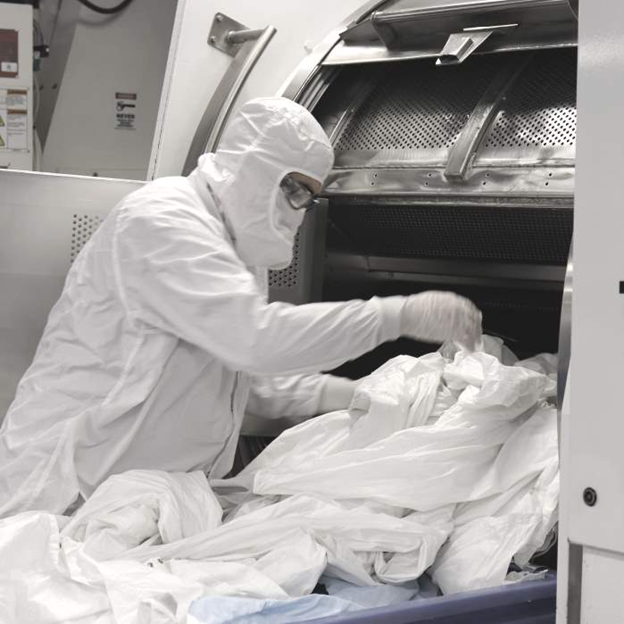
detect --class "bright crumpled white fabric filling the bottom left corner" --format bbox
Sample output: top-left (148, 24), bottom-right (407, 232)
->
top-left (0, 512), bottom-right (288, 624)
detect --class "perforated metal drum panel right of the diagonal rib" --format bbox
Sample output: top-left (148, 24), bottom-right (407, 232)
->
top-left (484, 49), bottom-right (576, 148)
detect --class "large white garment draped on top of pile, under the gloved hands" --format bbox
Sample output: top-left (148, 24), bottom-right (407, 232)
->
top-left (215, 353), bottom-right (554, 511)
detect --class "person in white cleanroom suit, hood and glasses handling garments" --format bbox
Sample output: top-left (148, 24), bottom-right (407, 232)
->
top-left (0, 98), bottom-right (481, 516)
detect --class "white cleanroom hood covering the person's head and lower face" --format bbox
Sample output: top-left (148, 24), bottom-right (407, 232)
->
top-left (198, 98), bottom-right (334, 269)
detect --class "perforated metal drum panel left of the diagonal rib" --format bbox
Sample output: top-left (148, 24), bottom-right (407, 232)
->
top-left (335, 55), bottom-right (506, 152)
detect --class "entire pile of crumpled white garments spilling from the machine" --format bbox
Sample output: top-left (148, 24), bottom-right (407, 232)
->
top-left (0, 343), bottom-right (559, 624)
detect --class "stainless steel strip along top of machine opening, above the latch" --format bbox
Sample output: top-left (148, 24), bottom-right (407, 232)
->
top-left (371, 0), bottom-right (576, 50)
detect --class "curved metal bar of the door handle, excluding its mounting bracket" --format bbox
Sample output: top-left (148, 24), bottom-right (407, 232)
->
top-left (183, 26), bottom-right (277, 175)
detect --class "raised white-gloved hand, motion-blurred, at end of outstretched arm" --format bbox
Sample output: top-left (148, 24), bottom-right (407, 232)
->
top-left (401, 290), bottom-right (481, 350)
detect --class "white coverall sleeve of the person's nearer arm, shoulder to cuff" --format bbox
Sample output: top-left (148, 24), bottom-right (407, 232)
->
top-left (113, 198), bottom-right (404, 375)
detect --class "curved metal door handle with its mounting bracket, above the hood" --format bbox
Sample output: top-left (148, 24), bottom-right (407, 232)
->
top-left (183, 13), bottom-right (277, 175)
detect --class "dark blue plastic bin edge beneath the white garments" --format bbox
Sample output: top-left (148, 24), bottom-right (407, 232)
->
top-left (310, 574), bottom-right (557, 624)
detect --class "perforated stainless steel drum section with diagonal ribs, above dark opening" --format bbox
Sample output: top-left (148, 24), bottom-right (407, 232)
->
top-left (317, 48), bottom-right (576, 184)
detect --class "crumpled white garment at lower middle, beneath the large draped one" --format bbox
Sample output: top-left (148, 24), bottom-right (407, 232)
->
top-left (126, 494), bottom-right (452, 596)
